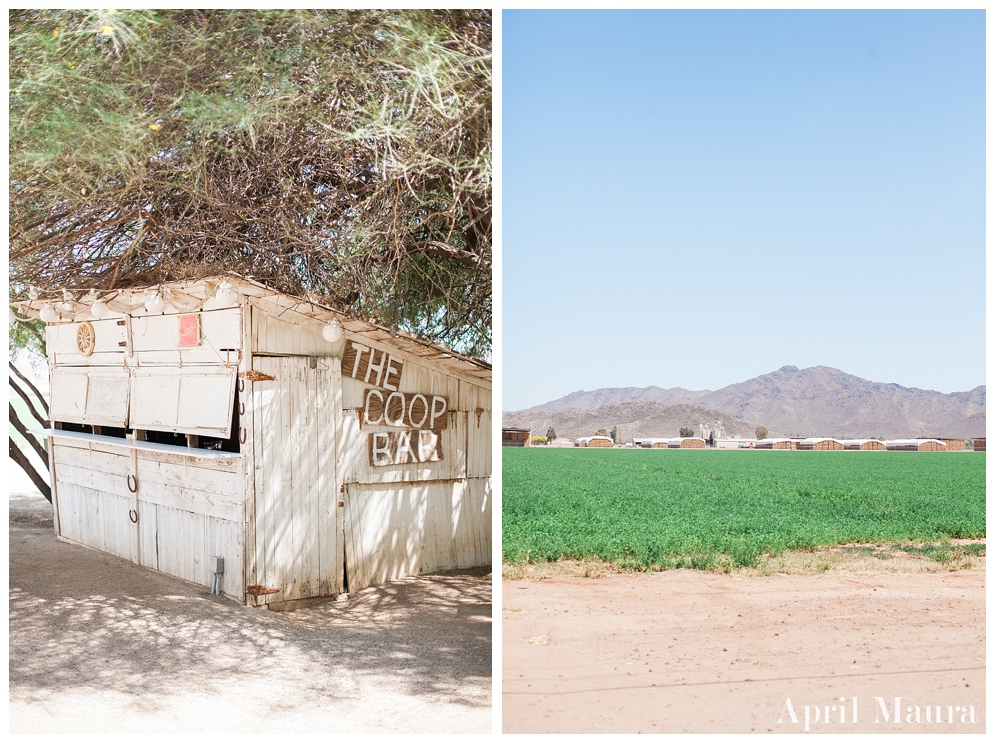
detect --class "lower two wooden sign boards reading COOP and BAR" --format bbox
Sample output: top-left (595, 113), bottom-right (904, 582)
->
top-left (360, 389), bottom-right (449, 467)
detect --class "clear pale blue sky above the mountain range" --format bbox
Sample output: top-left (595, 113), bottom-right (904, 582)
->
top-left (500, 11), bottom-right (985, 410)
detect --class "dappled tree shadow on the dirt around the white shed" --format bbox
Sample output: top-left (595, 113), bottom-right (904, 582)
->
top-left (9, 499), bottom-right (491, 710)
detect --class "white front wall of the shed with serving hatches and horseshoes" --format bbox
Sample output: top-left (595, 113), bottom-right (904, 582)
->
top-left (46, 308), bottom-right (245, 600)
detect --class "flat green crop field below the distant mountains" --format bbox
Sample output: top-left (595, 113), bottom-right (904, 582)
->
top-left (502, 448), bottom-right (985, 568)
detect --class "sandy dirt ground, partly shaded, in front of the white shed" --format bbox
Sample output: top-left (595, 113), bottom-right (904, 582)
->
top-left (9, 495), bottom-right (492, 733)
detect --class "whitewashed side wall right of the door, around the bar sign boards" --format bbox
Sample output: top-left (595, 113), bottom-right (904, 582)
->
top-left (341, 341), bottom-right (492, 590)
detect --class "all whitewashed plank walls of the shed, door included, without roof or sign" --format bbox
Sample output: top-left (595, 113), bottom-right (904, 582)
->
top-left (47, 308), bottom-right (492, 604)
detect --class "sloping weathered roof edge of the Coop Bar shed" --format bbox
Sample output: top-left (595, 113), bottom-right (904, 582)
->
top-left (11, 274), bottom-right (491, 389)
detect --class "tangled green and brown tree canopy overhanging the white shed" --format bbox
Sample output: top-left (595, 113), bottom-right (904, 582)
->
top-left (9, 10), bottom-right (492, 357)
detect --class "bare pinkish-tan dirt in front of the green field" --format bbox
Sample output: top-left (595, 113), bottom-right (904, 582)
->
top-left (502, 569), bottom-right (985, 733)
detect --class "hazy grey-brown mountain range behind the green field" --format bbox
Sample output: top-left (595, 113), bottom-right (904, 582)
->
top-left (502, 366), bottom-right (985, 440)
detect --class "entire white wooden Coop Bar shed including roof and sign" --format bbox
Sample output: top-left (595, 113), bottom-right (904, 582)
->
top-left (15, 276), bottom-right (492, 605)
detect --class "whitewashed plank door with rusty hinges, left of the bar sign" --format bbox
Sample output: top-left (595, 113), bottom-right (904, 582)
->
top-left (251, 356), bottom-right (344, 603)
